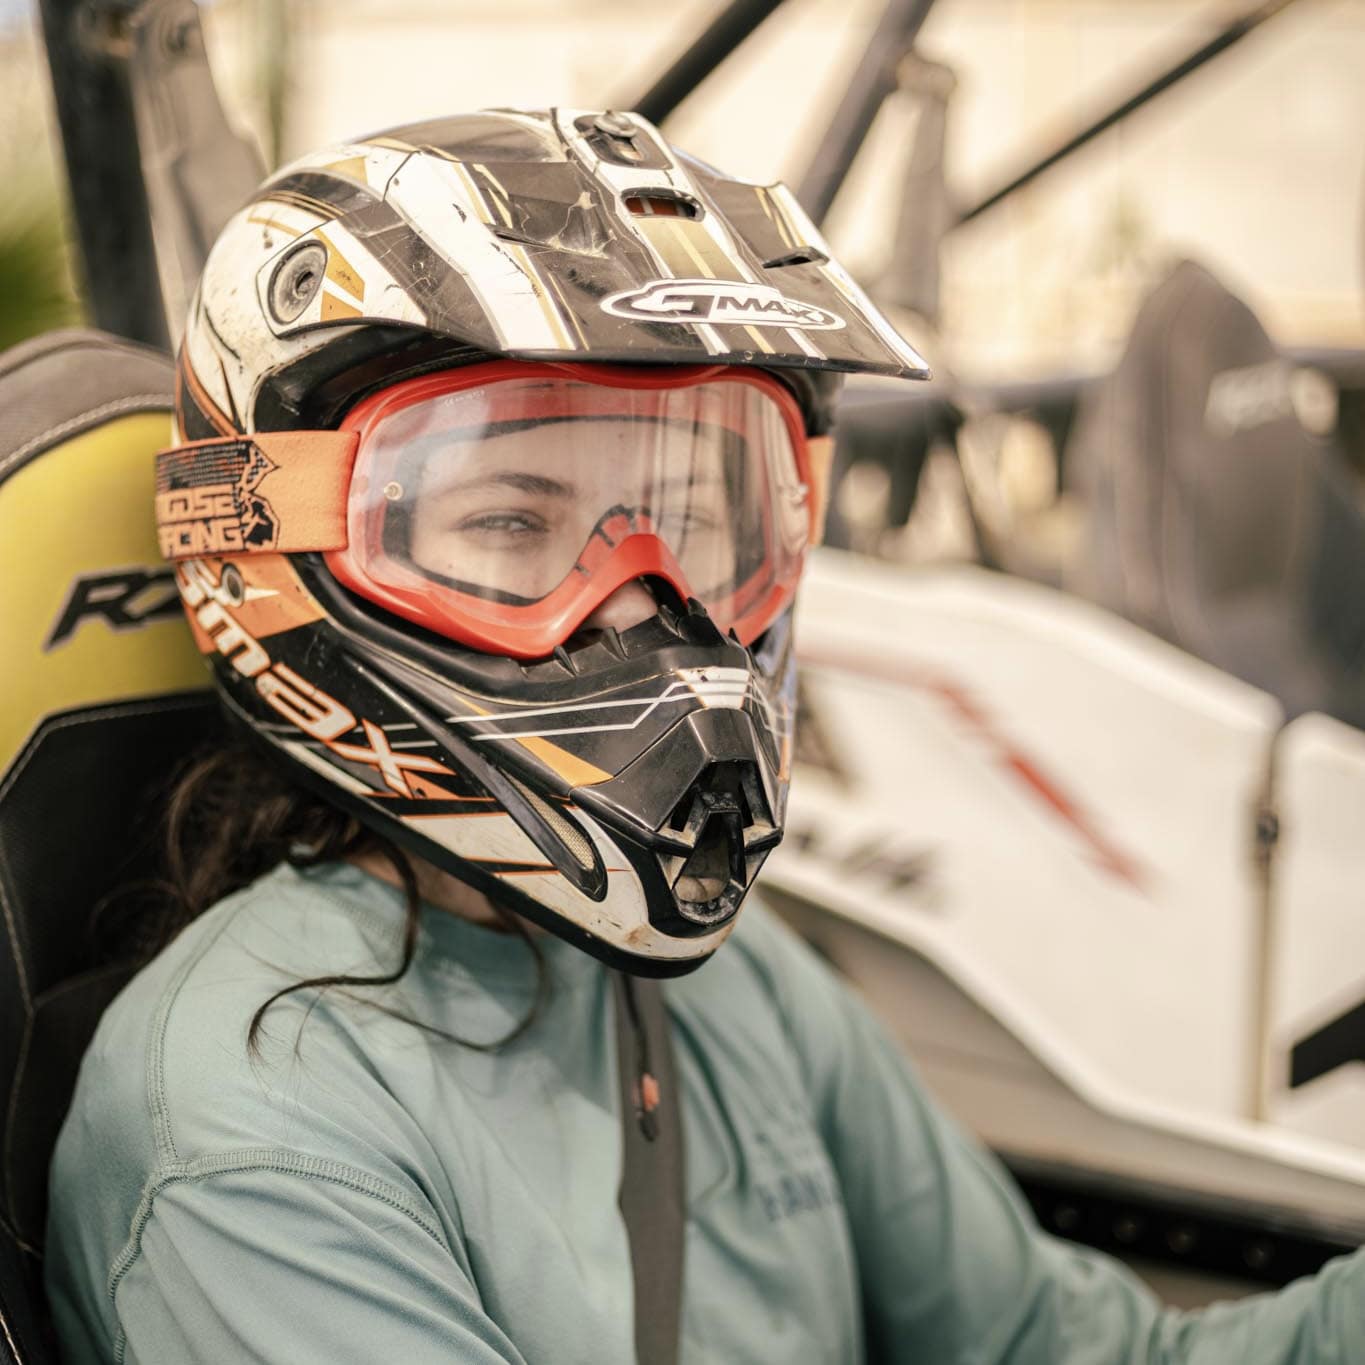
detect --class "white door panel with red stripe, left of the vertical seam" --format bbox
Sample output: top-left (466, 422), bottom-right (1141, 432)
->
top-left (766, 554), bottom-right (1280, 1115)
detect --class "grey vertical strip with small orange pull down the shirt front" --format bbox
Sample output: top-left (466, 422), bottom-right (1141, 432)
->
top-left (612, 972), bottom-right (687, 1365)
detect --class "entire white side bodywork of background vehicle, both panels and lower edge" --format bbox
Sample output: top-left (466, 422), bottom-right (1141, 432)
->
top-left (763, 553), bottom-right (1365, 1195)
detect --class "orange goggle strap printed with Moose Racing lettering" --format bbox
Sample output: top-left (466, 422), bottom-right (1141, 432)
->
top-left (156, 431), bottom-right (360, 560)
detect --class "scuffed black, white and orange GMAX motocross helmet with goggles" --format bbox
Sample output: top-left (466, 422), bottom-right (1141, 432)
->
top-left (157, 109), bottom-right (928, 976)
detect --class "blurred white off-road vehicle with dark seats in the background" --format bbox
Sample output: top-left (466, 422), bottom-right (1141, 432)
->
top-left (748, 5), bottom-right (1365, 1310)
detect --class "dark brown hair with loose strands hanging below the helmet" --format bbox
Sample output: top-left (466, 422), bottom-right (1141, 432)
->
top-left (152, 740), bottom-right (549, 1055)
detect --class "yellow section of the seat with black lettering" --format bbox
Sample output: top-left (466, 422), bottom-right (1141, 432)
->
top-left (0, 412), bottom-right (209, 773)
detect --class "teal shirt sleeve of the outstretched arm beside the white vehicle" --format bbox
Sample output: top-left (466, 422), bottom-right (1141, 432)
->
top-left (762, 911), bottom-right (1365, 1365)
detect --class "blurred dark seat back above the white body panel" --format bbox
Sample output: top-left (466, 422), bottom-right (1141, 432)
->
top-left (1067, 261), bottom-right (1365, 726)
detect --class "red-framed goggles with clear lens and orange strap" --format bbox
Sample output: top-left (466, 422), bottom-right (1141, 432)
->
top-left (157, 360), bottom-right (823, 658)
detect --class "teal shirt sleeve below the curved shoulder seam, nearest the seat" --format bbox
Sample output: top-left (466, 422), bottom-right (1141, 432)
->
top-left (115, 1168), bottom-right (521, 1365)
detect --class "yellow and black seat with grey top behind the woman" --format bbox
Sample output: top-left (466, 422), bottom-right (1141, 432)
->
top-left (0, 330), bottom-right (221, 1365)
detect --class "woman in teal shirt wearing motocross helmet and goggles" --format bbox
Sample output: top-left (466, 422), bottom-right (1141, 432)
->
top-left (48, 111), bottom-right (1365, 1365)
